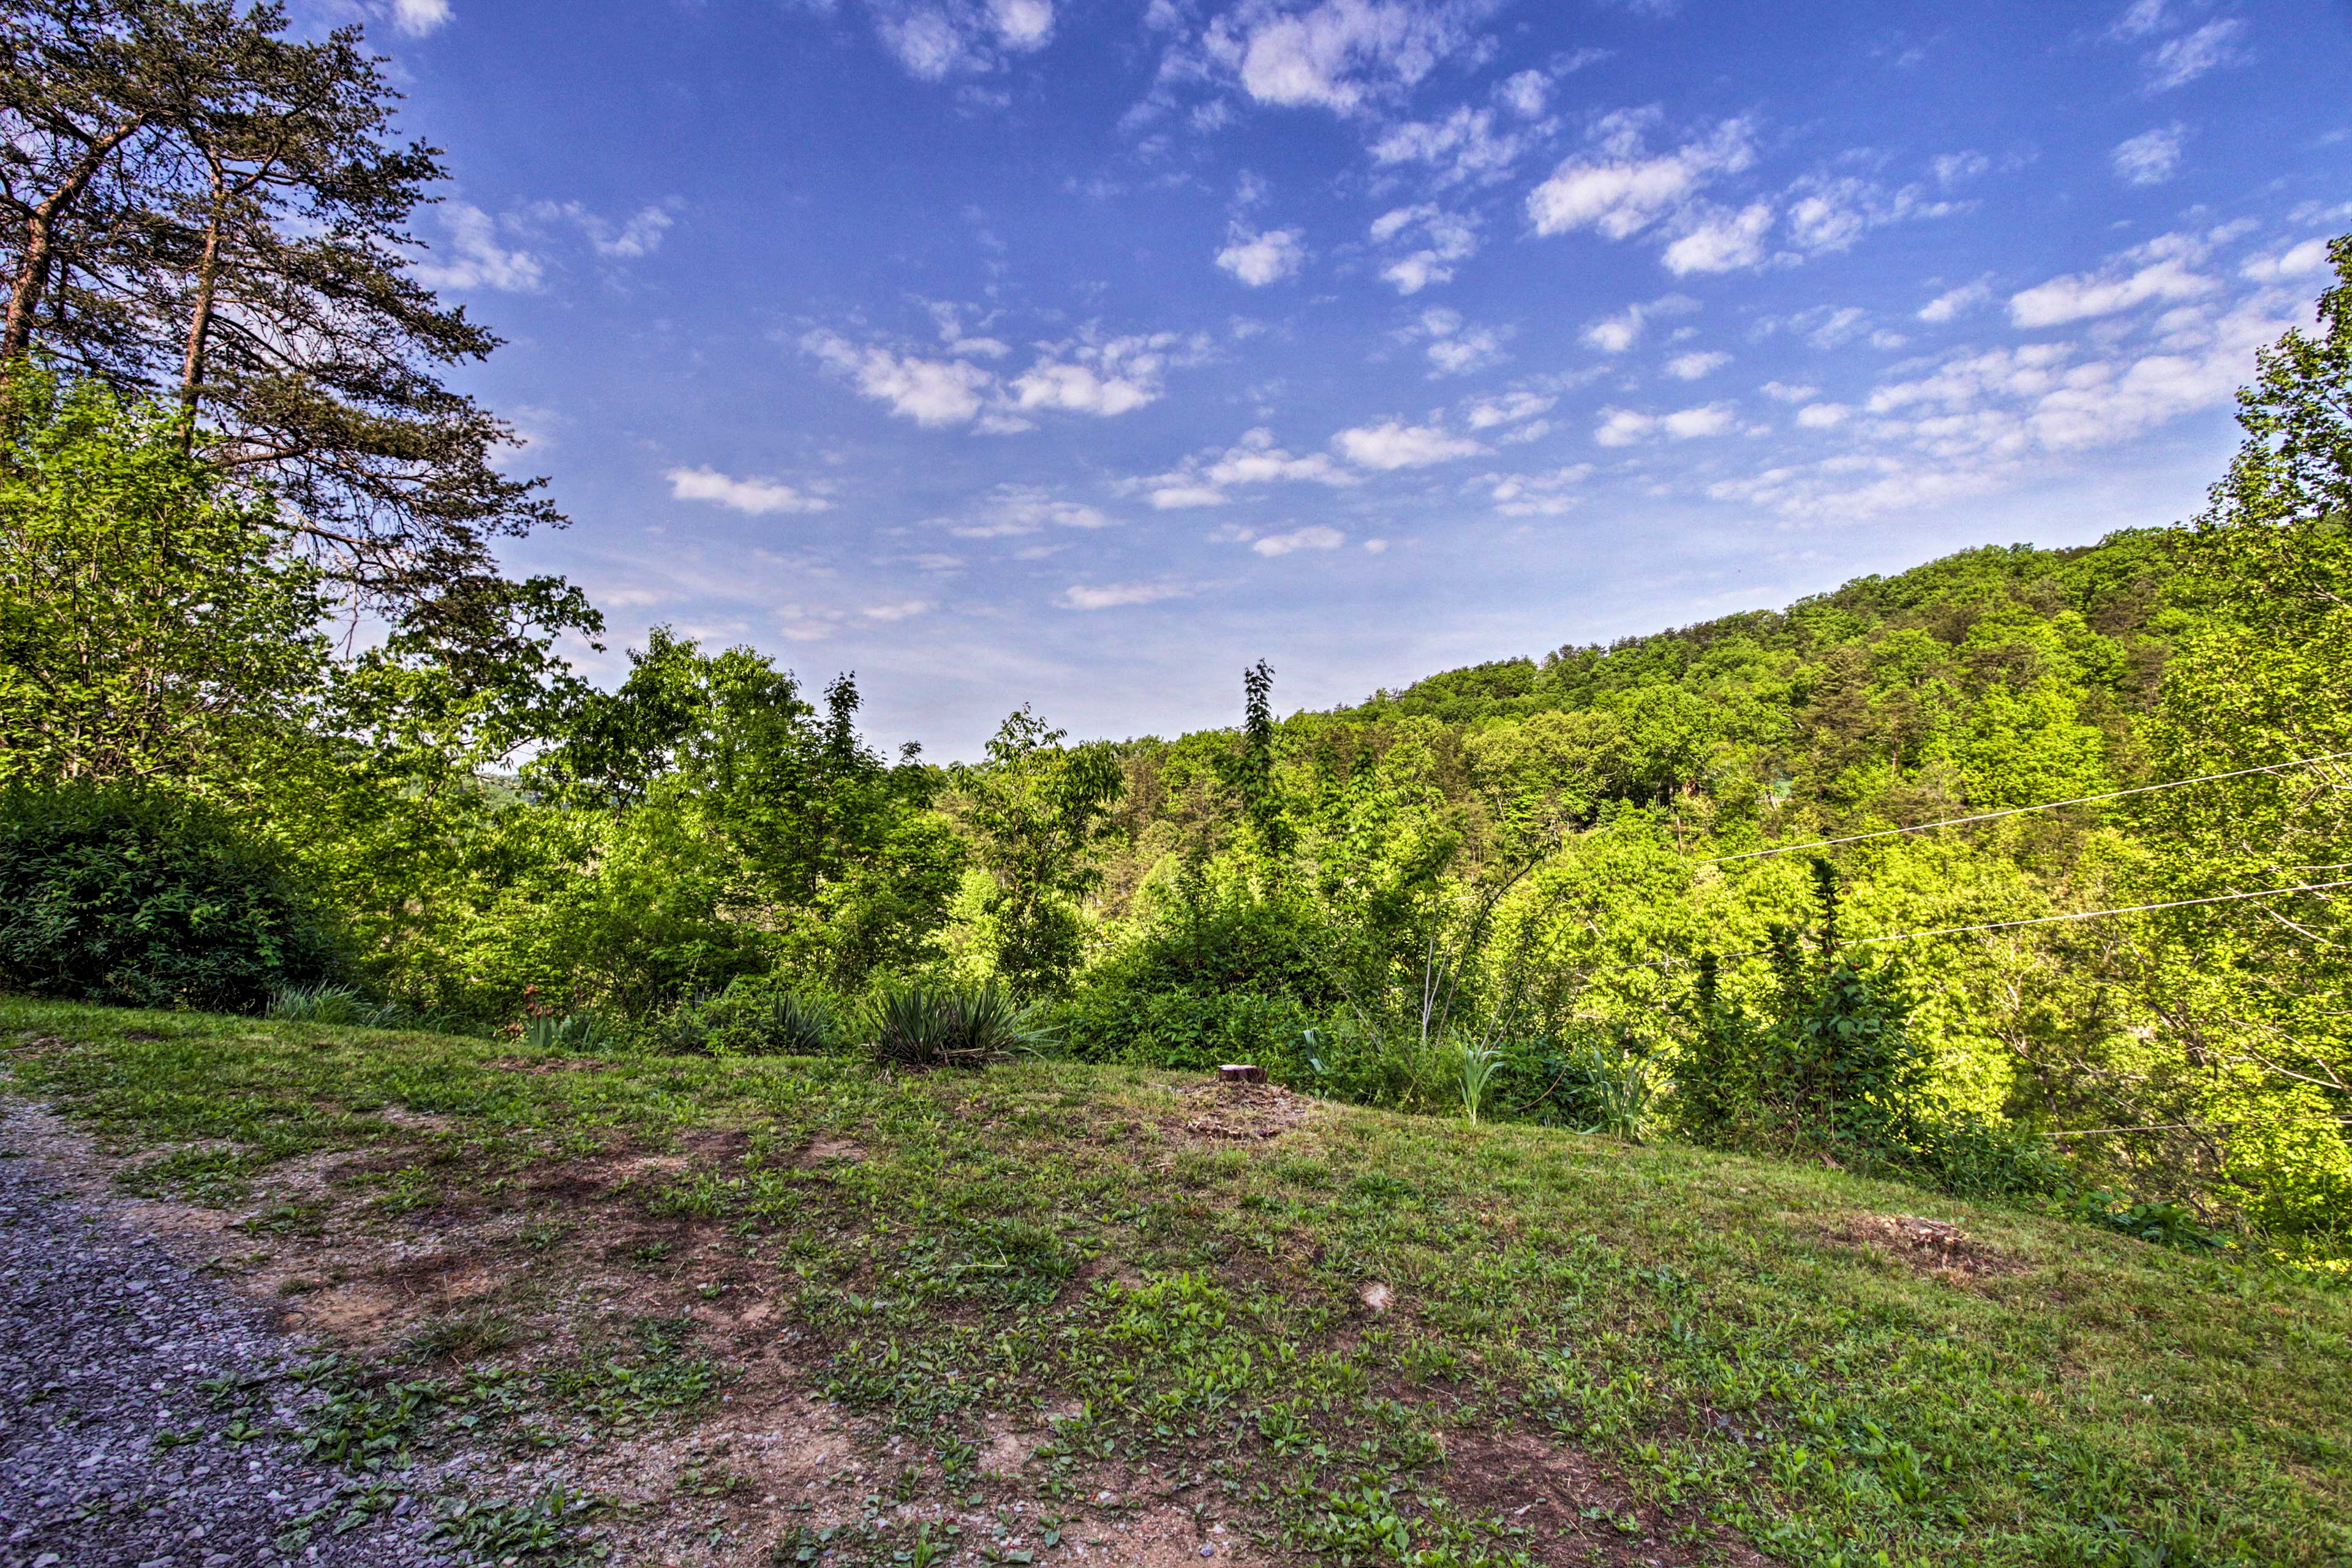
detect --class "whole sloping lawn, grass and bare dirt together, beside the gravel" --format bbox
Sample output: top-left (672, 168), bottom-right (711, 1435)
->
top-left (0, 1001), bottom-right (2352, 1568)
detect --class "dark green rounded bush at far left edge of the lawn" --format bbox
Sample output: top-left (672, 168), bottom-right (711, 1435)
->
top-left (0, 783), bottom-right (341, 1013)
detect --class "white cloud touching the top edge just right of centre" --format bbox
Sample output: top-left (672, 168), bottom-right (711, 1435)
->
top-left (1202, 0), bottom-right (1489, 115)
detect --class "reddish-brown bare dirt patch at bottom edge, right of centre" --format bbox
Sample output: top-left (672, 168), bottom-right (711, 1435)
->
top-left (1447, 1427), bottom-right (1771, 1568)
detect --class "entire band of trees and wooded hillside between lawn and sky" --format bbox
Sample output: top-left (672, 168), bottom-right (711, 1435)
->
top-left (0, 0), bottom-right (2352, 1260)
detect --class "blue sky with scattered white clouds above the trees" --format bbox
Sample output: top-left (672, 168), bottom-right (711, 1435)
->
top-left (306, 0), bottom-right (2352, 757)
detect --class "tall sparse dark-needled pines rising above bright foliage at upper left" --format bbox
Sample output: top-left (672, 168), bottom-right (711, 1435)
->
top-left (0, 0), bottom-right (593, 679)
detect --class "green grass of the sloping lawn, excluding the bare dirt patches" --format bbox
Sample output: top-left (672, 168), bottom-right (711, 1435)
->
top-left (0, 1001), bottom-right (2352, 1568)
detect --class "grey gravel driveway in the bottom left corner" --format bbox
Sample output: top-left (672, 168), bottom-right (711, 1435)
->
top-left (0, 1107), bottom-right (459, 1568)
